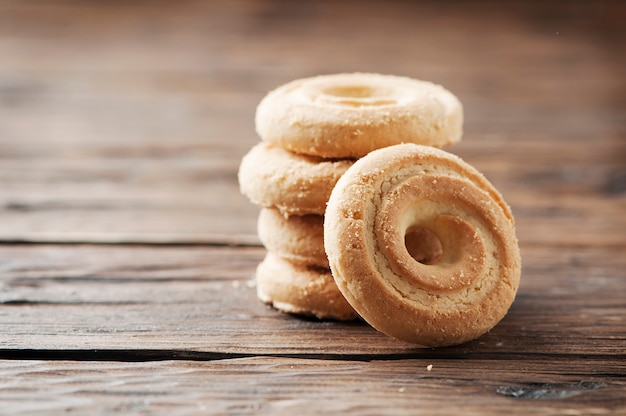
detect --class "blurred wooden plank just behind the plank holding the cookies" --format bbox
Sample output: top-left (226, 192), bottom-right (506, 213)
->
top-left (0, 156), bottom-right (626, 245)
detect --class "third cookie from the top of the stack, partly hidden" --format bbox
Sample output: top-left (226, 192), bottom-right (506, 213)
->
top-left (257, 208), bottom-right (329, 269)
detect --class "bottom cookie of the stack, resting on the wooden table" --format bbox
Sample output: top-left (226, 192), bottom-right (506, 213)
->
top-left (256, 253), bottom-right (358, 321)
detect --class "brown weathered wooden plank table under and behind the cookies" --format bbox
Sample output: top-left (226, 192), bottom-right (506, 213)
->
top-left (0, 0), bottom-right (626, 415)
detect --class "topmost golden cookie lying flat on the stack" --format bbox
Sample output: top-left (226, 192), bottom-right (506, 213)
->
top-left (255, 73), bottom-right (463, 158)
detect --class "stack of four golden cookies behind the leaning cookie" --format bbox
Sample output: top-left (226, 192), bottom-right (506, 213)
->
top-left (239, 73), bottom-right (463, 320)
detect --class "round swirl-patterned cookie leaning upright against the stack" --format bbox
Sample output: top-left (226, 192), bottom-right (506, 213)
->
top-left (324, 144), bottom-right (521, 346)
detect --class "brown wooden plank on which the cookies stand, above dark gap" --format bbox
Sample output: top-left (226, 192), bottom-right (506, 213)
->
top-left (0, 245), bottom-right (626, 359)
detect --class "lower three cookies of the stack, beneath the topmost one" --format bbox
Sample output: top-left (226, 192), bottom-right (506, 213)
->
top-left (239, 142), bottom-right (357, 320)
